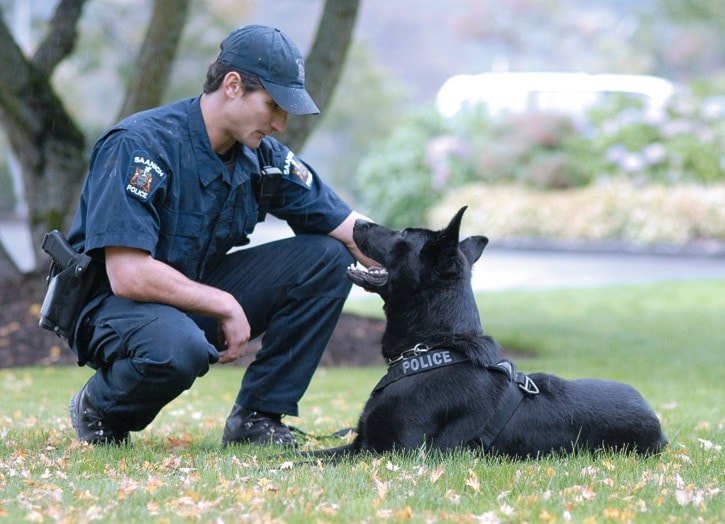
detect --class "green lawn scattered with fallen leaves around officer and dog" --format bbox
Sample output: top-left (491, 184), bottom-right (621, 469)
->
top-left (0, 281), bottom-right (725, 523)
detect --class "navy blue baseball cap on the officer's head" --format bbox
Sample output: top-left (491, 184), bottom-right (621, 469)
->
top-left (219, 25), bottom-right (320, 115)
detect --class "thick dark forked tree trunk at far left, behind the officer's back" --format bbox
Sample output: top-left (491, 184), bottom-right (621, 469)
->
top-left (0, 0), bottom-right (86, 270)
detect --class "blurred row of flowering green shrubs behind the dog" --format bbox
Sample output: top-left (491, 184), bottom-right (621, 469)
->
top-left (356, 78), bottom-right (725, 229)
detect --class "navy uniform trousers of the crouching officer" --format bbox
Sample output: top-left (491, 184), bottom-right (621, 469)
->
top-left (75, 235), bottom-right (354, 431)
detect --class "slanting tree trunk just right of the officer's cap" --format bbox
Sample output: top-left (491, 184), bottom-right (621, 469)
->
top-left (279, 0), bottom-right (360, 151)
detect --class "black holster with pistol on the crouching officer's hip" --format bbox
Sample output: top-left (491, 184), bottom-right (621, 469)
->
top-left (39, 231), bottom-right (103, 343)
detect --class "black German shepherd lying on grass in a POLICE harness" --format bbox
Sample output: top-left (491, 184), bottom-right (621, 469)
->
top-left (320, 207), bottom-right (667, 458)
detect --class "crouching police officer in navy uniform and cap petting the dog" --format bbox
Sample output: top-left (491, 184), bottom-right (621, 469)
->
top-left (69, 25), bottom-right (372, 445)
